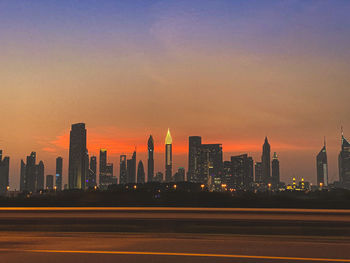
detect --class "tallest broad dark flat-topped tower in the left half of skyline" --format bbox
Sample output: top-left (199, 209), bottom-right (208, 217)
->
top-left (68, 123), bottom-right (89, 189)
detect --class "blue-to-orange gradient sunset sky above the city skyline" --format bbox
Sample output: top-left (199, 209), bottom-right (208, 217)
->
top-left (0, 0), bottom-right (350, 188)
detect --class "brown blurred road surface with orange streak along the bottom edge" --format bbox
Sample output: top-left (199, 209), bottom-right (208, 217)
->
top-left (0, 232), bottom-right (350, 263)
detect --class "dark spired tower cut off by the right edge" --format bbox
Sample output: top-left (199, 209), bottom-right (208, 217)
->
top-left (338, 130), bottom-right (350, 189)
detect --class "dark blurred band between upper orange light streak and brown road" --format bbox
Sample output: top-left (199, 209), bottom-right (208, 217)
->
top-left (0, 207), bottom-right (350, 236)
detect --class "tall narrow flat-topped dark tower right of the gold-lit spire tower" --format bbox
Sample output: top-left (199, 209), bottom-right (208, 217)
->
top-left (187, 136), bottom-right (202, 182)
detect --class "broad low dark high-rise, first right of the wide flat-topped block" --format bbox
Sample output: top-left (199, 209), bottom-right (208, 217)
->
top-left (229, 154), bottom-right (254, 189)
